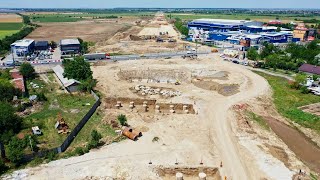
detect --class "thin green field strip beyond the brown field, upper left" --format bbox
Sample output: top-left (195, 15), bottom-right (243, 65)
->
top-left (30, 12), bottom-right (154, 23)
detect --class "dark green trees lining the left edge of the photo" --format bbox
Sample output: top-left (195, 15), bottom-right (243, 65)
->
top-left (0, 63), bottom-right (37, 173)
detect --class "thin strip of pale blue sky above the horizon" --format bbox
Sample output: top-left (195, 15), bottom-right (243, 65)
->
top-left (0, 0), bottom-right (320, 9)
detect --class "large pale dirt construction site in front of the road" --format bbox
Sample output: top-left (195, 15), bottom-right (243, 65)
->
top-left (4, 54), bottom-right (307, 180)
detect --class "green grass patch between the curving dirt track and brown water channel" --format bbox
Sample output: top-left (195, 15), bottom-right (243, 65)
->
top-left (255, 72), bottom-right (320, 133)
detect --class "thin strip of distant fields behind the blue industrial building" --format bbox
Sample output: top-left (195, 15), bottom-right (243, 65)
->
top-left (167, 13), bottom-right (320, 22)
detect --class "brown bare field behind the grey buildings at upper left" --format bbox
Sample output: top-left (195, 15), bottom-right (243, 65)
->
top-left (27, 17), bottom-right (137, 42)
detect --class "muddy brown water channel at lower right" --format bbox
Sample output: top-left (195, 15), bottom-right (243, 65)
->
top-left (264, 117), bottom-right (320, 173)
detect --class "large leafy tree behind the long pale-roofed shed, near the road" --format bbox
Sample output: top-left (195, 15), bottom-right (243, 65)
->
top-left (63, 57), bottom-right (92, 81)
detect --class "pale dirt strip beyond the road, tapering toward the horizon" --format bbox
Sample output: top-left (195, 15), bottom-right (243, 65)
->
top-left (91, 14), bottom-right (210, 54)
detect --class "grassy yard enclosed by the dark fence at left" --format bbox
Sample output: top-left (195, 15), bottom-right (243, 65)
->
top-left (23, 75), bottom-right (95, 149)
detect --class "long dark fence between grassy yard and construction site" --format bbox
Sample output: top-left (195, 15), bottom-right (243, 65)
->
top-left (20, 91), bottom-right (101, 161)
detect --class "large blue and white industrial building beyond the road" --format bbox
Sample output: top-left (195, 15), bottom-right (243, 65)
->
top-left (188, 19), bottom-right (295, 45)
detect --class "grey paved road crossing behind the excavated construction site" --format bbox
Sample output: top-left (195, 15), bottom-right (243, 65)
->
top-left (0, 51), bottom-right (211, 68)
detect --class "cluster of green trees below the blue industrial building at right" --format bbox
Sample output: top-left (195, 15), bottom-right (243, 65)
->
top-left (247, 40), bottom-right (320, 71)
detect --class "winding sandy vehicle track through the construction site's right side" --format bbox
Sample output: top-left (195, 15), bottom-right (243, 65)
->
top-left (199, 62), bottom-right (269, 179)
